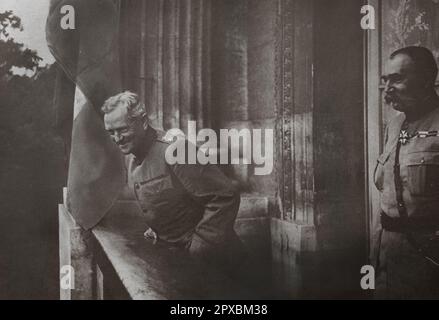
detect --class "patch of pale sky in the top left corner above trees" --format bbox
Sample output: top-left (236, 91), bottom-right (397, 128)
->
top-left (0, 0), bottom-right (55, 72)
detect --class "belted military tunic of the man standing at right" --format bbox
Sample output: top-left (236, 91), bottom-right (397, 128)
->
top-left (373, 108), bottom-right (439, 298)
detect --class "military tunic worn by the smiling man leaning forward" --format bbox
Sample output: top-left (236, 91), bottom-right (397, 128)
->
top-left (127, 127), bottom-right (240, 258)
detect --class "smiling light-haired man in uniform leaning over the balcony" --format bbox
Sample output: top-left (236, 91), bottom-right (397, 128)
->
top-left (102, 91), bottom-right (241, 264)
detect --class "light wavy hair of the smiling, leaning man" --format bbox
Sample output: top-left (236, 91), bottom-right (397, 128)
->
top-left (101, 91), bottom-right (146, 121)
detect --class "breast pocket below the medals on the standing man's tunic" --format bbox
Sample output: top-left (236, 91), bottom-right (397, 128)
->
top-left (407, 152), bottom-right (439, 196)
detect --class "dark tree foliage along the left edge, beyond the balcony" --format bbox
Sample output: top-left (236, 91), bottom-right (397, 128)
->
top-left (0, 11), bottom-right (66, 299)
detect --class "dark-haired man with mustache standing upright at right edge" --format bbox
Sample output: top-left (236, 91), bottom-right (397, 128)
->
top-left (373, 46), bottom-right (439, 299)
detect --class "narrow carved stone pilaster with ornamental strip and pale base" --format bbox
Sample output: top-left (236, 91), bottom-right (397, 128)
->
top-left (272, 0), bottom-right (317, 260)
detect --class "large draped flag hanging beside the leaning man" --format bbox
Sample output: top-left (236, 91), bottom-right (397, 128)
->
top-left (46, 0), bottom-right (125, 229)
